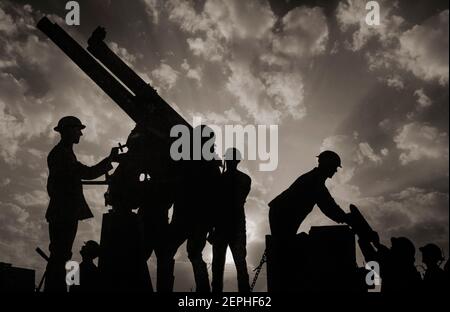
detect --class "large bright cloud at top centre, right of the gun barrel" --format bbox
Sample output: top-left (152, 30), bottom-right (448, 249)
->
top-left (163, 1), bottom-right (328, 124)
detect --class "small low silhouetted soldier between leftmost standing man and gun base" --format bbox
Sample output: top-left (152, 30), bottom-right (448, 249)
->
top-left (70, 240), bottom-right (101, 292)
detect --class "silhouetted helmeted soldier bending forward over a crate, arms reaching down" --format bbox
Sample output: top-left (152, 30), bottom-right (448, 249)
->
top-left (267, 151), bottom-right (348, 291)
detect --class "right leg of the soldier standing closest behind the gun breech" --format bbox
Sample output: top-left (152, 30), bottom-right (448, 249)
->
top-left (187, 226), bottom-right (211, 292)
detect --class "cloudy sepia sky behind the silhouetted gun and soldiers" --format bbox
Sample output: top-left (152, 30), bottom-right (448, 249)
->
top-left (0, 0), bottom-right (449, 290)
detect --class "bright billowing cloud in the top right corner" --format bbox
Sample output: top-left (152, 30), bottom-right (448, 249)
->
top-left (337, 0), bottom-right (449, 85)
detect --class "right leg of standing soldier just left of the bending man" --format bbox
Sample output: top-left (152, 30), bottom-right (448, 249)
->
top-left (230, 229), bottom-right (250, 292)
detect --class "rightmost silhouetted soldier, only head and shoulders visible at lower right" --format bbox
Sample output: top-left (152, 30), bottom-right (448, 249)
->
top-left (419, 244), bottom-right (448, 292)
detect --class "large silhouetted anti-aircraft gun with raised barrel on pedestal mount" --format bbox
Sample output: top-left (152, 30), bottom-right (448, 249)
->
top-left (37, 17), bottom-right (219, 290)
